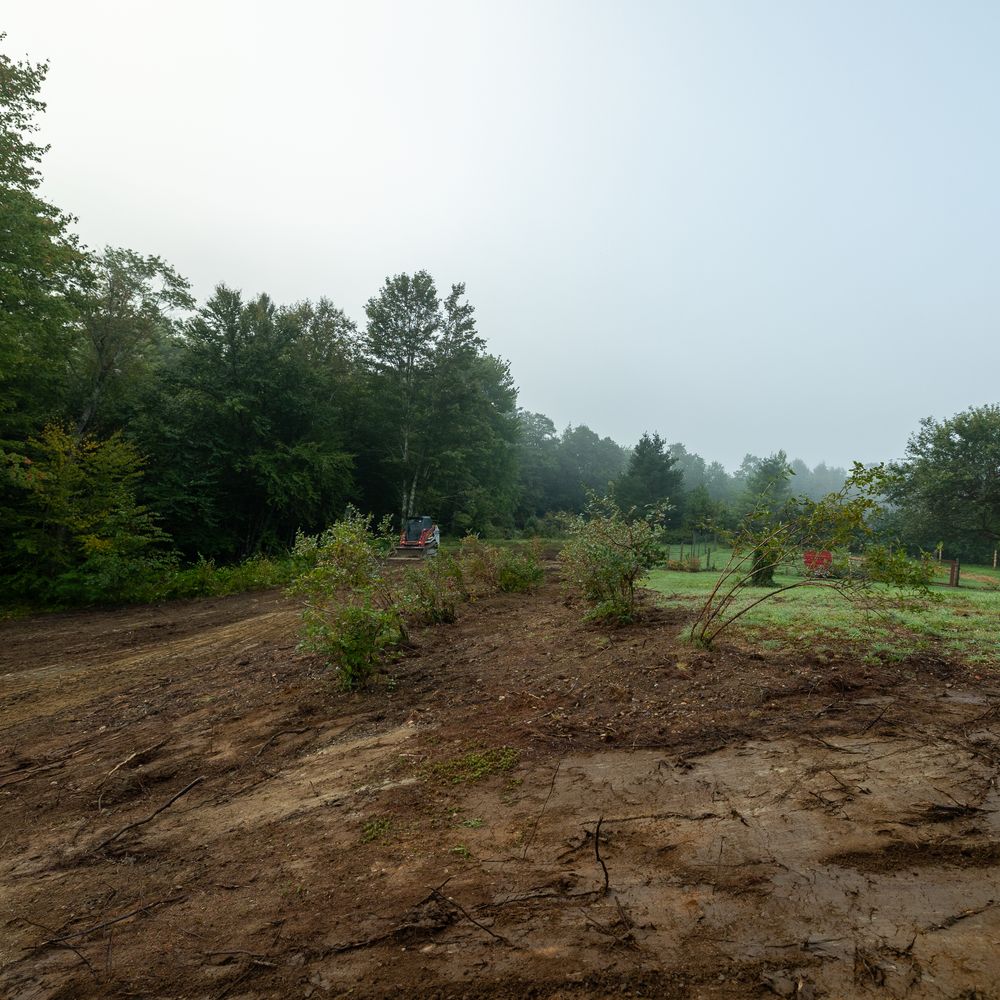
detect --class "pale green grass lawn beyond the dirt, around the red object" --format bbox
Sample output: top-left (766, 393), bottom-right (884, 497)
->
top-left (646, 552), bottom-right (1000, 664)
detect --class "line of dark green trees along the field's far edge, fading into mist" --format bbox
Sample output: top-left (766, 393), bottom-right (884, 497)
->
top-left (0, 36), bottom-right (1000, 598)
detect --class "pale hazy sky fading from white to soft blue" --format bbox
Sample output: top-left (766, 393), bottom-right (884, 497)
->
top-left (0, 0), bottom-right (1000, 468)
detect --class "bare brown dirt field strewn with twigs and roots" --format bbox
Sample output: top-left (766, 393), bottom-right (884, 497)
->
top-left (0, 581), bottom-right (1000, 1000)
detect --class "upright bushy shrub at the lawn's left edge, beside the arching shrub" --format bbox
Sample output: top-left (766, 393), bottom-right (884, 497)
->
top-left (559, 497), bottom-right (662, 623)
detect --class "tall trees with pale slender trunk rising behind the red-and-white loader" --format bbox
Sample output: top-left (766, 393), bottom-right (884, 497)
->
top-left (359, 271), bottom-right (517, 527)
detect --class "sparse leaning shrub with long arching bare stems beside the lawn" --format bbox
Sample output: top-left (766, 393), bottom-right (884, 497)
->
top-left (690, 463), bottom-right (930, 645)
